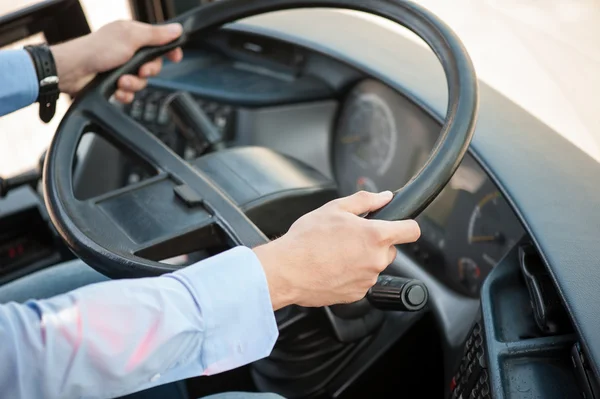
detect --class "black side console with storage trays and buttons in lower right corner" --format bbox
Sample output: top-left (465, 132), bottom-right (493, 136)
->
top-left (448, 242), bottom-right (600, 399)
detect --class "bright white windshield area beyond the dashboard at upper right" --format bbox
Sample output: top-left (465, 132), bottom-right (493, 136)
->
top-left (418, 0), bottom-right (600, 160)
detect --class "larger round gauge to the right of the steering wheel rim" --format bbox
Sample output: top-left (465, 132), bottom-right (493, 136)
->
top-left (468, 191), bottom-right (513, 267)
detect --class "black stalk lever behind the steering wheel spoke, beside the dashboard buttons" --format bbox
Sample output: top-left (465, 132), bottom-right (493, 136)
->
top-left (165, 91), bottom-right (225, 155)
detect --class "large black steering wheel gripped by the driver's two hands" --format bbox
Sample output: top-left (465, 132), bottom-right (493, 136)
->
top-left (43, 0), bottom-right (478, 278)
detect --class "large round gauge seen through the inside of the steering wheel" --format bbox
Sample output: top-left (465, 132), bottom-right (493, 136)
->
top-left (334, 90), bottom-right (397, 195)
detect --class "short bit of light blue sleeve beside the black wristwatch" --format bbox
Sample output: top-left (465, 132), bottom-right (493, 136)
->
top-left (0, 50), bottom-right (39, 116)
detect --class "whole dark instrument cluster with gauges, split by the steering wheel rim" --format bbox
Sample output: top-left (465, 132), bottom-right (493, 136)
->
top-left (333, 80), bottom-right (524, 296)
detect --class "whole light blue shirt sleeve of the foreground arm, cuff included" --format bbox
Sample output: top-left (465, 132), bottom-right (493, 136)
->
top-left (0, 247), bottom-right (278, 399)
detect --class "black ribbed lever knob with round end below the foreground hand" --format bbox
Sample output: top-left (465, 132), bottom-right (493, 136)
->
top-left (367, 276), bottom-right (429, 312)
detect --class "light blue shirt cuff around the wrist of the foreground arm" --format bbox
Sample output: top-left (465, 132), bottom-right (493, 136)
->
top-left (169, 247), bottom-right (279, 375)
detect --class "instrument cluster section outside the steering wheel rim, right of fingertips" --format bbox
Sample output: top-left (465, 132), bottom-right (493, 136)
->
top-left (412, 154), bottom-right (524, 296)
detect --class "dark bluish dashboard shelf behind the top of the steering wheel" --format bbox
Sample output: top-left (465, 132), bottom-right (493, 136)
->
top-left (152, 32), bottom-right (334, 107)
